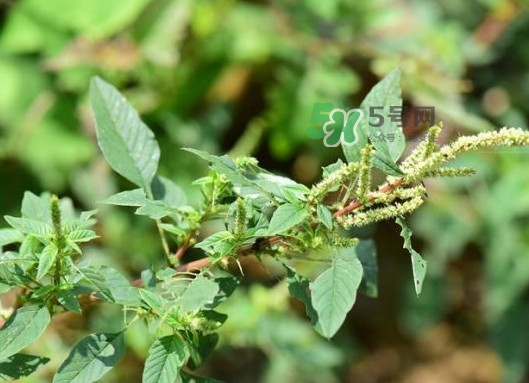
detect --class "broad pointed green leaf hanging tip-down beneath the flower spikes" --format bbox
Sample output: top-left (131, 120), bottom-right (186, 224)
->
top-left (310, 247), bottom-right (363, 338)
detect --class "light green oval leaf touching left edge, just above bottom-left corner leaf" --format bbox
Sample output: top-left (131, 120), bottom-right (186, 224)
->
top-left (0, 306), bottom-right (50, 360)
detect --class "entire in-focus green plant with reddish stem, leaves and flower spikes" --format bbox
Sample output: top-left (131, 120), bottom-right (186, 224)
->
top-left (0, 70), bottom-right (529, 382)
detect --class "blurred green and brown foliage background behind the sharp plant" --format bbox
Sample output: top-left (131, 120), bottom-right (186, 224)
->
top-left (0, 0), bottom-right (529, 383)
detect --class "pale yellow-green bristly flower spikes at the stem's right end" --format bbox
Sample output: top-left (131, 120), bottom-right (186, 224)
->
top-left (309, 124), bottom-right (529, 229)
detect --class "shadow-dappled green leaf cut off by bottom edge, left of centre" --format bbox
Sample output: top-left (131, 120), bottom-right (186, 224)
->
top-left (53, 332), bottom-right (125, 383)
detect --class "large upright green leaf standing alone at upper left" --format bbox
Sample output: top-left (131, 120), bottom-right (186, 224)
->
top-left (90, 77), bottom-right (160, 192)
